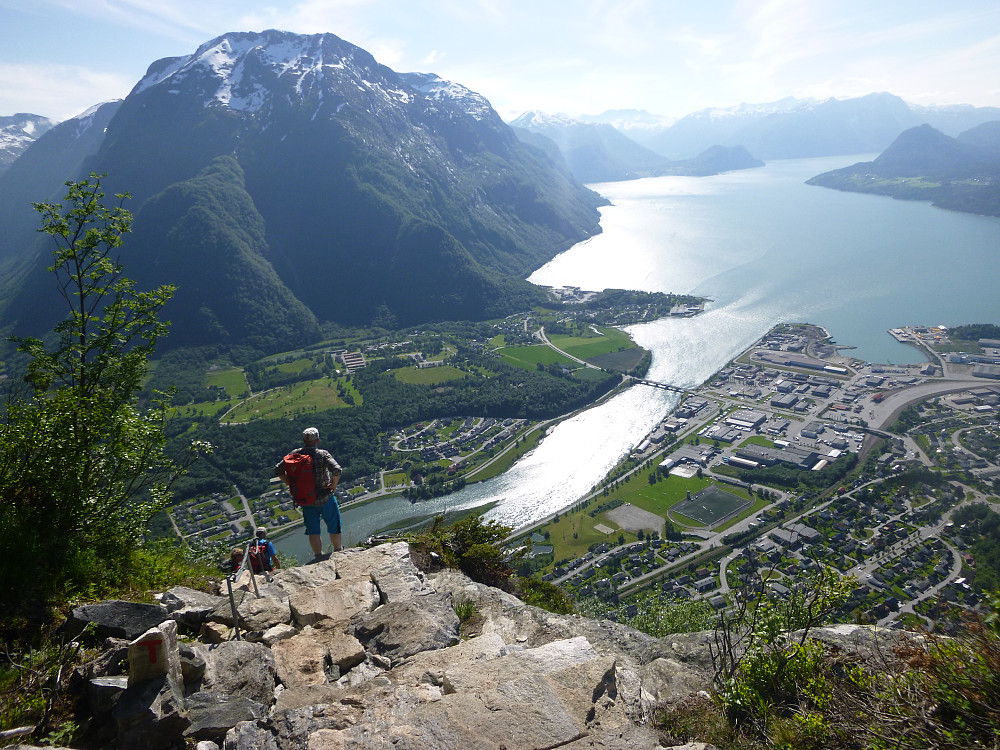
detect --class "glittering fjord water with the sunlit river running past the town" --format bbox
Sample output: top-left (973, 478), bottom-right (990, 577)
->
top-left (279, 156), bottom-right (1000, 556)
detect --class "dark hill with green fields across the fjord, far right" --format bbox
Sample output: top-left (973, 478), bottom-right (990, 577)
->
top-left (808, 123), bottom-right (1000, 216)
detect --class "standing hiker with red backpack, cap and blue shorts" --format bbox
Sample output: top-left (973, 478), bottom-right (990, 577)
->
top-left (274, 427), bottom-right (344, 560)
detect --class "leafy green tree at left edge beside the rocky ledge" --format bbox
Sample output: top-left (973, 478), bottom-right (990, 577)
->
top-left (0, 175), bottom-right (207, 601)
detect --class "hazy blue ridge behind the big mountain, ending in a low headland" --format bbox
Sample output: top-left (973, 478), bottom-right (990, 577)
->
top-left (510, 111), bottom-right (763, 183)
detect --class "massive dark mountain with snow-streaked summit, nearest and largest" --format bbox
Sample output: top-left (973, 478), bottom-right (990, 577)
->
top-left (0, 31), bottom-right (602, 342)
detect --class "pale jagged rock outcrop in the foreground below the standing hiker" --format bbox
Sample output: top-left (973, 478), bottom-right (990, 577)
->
top-left (47, 543), bottom-right (724, 750)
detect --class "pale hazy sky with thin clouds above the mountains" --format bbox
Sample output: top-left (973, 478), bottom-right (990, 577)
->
top-left (0, 0), bottom-right (1000, 120)
